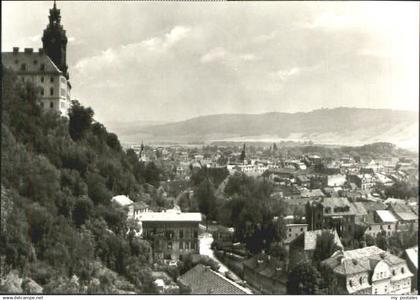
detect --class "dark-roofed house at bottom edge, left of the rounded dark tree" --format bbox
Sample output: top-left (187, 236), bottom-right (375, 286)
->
top-left (243, 254), bottom-right (287, 294)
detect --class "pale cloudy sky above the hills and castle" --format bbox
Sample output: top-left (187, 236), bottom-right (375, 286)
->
top-left (2, 1), bottom-right (419, 124)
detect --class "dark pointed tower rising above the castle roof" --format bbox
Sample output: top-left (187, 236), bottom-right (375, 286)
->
top-left (42, 0), bottom-right (69, 80)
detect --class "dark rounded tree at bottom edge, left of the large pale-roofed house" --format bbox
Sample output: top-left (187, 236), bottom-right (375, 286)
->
top-left (287, 262), bottom-right (323, 295)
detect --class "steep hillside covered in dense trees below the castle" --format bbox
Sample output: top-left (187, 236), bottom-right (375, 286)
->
top-left (0, 69), bottom-right (162, 293)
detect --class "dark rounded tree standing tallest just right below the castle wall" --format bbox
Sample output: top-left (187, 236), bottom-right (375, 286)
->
top-left (68, 100), bottom-right (93, 141)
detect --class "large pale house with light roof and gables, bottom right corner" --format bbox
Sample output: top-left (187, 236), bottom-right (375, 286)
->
top-left (321, 246), bottom-right (413, 295)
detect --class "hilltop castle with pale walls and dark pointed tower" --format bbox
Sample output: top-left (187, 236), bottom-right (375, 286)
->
top-left (1, 1), bottom-right (71, 115)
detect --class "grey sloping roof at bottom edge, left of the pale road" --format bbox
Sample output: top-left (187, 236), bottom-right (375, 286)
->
top-left (178, 264), bottom-right (251, 295)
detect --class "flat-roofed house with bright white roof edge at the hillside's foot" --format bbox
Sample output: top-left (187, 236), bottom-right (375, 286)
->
top-left (137, 210), bottom-right (202, 261)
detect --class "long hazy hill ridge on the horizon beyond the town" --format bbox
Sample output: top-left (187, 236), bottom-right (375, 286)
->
top-left (119, 107), bottom-right (418, 150)
